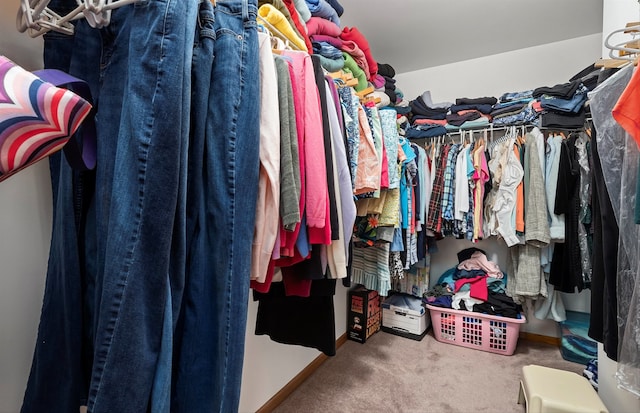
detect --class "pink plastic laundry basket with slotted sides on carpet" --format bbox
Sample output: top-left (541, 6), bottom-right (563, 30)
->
top-left (427, 304), bottom-right (527, 356)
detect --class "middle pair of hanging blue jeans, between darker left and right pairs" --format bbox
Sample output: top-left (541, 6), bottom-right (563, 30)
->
top-left (88, 0), bottom-right (198, 412)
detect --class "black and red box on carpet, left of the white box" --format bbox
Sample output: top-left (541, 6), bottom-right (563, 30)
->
top-left (347, 285), bottom-right (381, 343)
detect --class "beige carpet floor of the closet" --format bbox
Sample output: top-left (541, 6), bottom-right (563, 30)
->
top-left (274, 329), bottom-right (584, 413)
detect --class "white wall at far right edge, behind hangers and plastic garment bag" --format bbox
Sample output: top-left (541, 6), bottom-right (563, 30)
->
top-left (598, 0), bottom-right (640, 413)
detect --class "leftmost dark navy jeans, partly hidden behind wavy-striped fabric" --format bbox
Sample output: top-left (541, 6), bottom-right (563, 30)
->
top-left (21, 0), bottom-right (98, 412)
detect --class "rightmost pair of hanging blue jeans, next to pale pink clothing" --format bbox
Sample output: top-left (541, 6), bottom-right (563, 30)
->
top-left (172, 0), bottom-right (260, 413)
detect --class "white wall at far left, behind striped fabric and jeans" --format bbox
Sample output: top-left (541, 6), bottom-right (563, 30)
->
top-left (0, 0), bottom-right (52, 413)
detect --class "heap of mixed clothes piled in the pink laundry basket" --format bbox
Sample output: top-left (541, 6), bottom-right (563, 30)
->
top-left (423, 247), bottom-right (522, 318)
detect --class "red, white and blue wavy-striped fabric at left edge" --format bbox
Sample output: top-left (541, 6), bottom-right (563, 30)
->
top-left (0, 56), bottom-right (91, 181)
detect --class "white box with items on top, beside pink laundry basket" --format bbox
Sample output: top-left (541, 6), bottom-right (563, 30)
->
top-left (382, 294), bottom-right (431, 340)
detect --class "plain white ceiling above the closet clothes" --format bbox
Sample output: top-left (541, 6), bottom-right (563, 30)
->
top-left (338, 0), bottom-right (603, 73)
